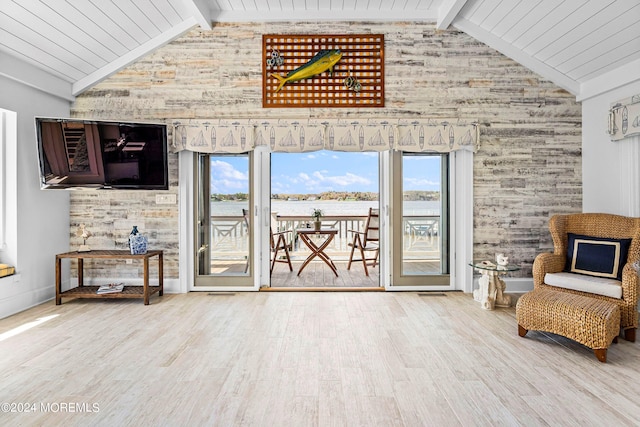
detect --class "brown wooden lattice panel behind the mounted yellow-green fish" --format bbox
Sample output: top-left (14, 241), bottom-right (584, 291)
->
top-left (262, 34), bottom-right (384, 108)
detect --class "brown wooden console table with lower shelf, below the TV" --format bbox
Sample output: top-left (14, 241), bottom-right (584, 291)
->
top-left (56, 250), bottom-right (164, 305)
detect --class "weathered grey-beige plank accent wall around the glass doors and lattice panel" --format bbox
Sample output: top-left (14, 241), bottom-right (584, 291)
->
top-left (70, 22), bottom-right (582, 278)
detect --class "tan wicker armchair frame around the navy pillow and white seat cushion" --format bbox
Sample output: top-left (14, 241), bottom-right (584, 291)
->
top-left (533, 213), bottom-right (640, 341)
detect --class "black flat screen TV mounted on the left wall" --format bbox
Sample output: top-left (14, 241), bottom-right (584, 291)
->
top-left (36, 117), bottom-right (169, 190)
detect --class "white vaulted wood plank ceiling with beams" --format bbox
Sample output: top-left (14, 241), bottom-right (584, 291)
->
top-left (0, 0), bottom-right (640, 100)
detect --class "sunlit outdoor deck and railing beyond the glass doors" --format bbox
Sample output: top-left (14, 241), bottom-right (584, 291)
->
top-left (205, 215), bottom-right (440, 289)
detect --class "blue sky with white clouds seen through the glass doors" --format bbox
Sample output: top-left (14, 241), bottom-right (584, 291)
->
top-left (211, 150), bottom-right (440, 194)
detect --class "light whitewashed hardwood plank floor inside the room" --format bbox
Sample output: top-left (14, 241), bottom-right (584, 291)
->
top-left (0, 292), bottom-right (640, 426)
